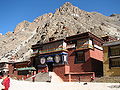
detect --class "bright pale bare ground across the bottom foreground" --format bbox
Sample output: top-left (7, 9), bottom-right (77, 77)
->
top-left (0, 79), bottom-right (120, 90)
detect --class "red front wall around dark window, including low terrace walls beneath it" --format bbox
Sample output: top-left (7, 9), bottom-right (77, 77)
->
top-left (53, 49), bottom-right (96, 82)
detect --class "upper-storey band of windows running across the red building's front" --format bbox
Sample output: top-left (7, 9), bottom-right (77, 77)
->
top-left (33, 38), bottom-right (93, 53)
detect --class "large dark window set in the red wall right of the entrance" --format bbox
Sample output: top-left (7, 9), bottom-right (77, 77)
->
top-left (75, 51), bottom-right (85, 64)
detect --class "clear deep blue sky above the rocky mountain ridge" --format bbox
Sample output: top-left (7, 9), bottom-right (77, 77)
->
top-left (0, 0), bottom-right (120, 34)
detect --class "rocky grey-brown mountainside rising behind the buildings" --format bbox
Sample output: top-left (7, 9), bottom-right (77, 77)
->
top-left (0, 2), bottom-right (120, 62)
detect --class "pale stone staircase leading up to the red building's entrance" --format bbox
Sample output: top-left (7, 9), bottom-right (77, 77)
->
top-left (26, 72), bottom-right (63, 82)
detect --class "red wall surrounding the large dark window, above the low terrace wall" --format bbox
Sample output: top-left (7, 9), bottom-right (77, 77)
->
top-left (68, 49), bottom-right (92, 72)
